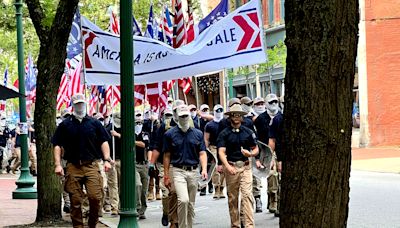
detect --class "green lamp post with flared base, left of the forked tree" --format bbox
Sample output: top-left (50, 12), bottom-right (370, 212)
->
top-left (12, 0), bottom-right (37, 199)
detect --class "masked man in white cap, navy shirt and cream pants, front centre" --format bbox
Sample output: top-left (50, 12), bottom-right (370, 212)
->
top-left (163, 105), bottom-right (207, 227)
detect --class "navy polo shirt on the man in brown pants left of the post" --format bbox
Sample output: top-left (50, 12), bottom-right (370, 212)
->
top-left (51, 116), bottom-right (110, 164)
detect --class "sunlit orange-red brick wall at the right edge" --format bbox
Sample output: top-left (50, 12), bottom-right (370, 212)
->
top-left (365, 0), bottom-right (400, 146)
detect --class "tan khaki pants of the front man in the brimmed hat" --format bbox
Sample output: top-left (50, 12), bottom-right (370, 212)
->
top-left (225, 165), bottom-right (254, 228)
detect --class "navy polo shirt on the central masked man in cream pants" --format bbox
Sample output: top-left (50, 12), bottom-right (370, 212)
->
top-left (163, 127), bottom-right (206, 166)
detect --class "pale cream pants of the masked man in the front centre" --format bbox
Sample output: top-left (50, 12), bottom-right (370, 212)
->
top-left (172, 167), bottom-right (199, 228)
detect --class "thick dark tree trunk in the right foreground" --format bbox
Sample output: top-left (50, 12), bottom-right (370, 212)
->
top-left (280, 0), bottom-right (359, 227)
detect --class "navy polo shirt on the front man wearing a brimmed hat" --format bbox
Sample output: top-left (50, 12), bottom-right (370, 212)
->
top-left (217, 125), bottom-right (257, 162)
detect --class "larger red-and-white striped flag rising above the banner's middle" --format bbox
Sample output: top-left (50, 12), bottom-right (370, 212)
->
top-left (173, 0), bottom-right (186, 48)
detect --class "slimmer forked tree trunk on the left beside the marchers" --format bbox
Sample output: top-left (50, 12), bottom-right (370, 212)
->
top-left (26, 0), bottom-right (79, 224)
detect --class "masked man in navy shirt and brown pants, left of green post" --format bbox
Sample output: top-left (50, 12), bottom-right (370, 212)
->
top-left (52, 94), bottom-right (113, 227)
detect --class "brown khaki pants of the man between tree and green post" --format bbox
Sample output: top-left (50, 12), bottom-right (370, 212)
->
top-left (65, 162), bottom-right (103, 228)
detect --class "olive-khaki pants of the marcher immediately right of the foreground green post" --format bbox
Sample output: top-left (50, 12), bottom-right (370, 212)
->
top-left (136, 164), bottom-right (149, 215)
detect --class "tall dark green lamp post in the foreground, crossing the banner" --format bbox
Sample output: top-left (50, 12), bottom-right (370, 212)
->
top-left (118, 0), bottom-right (138, 225)
